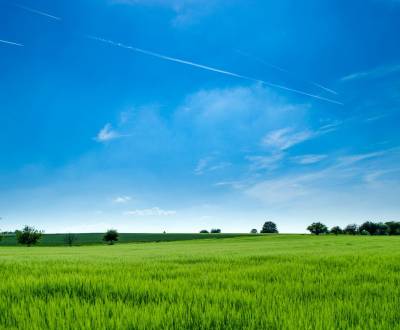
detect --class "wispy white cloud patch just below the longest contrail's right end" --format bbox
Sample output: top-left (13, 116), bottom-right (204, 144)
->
top-left (262, 127), bottom-right (315, 150)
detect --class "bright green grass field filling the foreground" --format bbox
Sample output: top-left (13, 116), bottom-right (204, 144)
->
top-left (0, 235), bottom-right (400, 329)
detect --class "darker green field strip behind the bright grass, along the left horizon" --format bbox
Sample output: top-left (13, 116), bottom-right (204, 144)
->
top-left (0, 233), bottom-right (249, 246)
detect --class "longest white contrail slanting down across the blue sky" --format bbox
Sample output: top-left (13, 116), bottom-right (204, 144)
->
top-left (87, 36), bottom-right (343, 105)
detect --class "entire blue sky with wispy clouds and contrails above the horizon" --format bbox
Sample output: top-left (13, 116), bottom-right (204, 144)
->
top-left (0, 0), bottom-right (400, 232)
